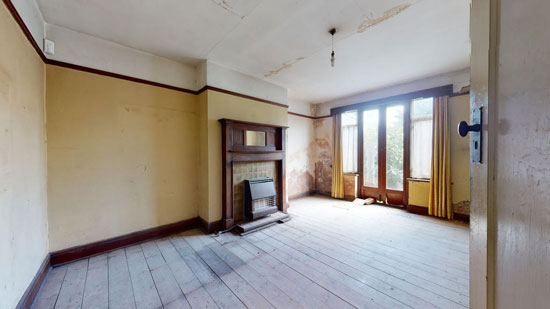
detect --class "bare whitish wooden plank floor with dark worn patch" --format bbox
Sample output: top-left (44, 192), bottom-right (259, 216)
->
top-left (34, 197), bottom-right (469, 308)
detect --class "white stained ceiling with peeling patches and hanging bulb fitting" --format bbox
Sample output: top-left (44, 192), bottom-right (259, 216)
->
top-left (36, 0), bottom-right (470, 103)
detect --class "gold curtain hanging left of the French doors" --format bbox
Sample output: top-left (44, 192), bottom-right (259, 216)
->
top-left (331, 114), bottom-right (344, 198)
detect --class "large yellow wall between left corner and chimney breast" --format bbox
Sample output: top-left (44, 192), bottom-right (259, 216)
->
top-left (46, 65), bottom-right (199, 251)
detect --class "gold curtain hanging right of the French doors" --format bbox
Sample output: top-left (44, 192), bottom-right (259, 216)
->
top-left (428, 96), bottom-right (453, 219)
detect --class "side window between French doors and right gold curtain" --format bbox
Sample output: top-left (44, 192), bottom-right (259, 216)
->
top-left (410, 98), bottom-right (433, 179)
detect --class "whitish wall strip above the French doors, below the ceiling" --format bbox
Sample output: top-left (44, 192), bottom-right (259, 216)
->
top-left (315, 69), bottom-right (470, 116)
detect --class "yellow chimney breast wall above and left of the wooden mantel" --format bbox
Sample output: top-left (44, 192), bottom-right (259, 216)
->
top-left (199, 90), bottom-right (288, 222)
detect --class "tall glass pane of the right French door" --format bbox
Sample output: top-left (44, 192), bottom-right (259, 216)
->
top-left (386, 105), bottom-right (404, 191)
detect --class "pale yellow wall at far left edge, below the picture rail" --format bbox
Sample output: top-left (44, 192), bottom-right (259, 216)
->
top-left (0, 5), bottom-right (48, 309)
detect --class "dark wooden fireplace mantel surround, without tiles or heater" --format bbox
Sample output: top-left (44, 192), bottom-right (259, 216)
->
top-left (219, 118), bottom-right (288, 229)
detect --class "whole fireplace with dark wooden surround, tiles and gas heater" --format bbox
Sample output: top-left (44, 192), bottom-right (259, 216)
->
top-left (219, 119), bottom-right (288, 230)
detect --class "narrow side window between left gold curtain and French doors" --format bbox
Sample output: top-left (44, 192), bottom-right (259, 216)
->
top-left (342, 111), bottom-right (357, 173)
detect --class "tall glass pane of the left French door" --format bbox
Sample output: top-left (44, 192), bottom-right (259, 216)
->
top-left (363, 109), bottom-right (378, 187)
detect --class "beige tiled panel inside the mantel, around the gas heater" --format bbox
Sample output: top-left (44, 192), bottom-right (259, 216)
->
top-left (233, 161), bottom-right (279, 222)
